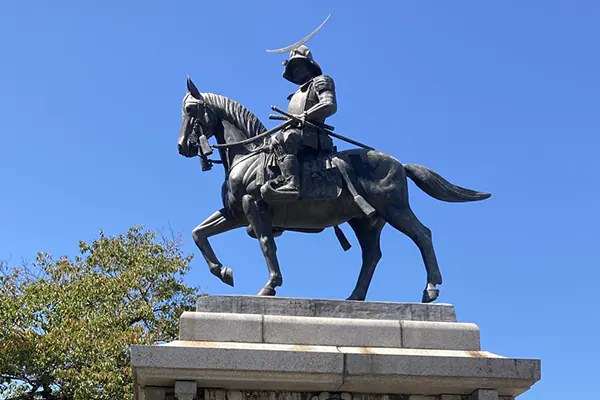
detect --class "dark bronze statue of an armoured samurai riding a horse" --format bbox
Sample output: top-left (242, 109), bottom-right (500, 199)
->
top-left (178, 17), bottom-right (490, 302)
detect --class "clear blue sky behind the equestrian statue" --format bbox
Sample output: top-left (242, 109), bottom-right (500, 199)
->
top-left (0, 0), bottom-right (600, 400)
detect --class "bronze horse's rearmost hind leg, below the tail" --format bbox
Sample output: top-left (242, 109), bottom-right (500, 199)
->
top-left (383, 204), bottom-right (442, 303)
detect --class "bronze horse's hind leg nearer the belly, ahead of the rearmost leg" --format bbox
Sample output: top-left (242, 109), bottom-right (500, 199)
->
top-left (348, 216), bottom-right (385, 300)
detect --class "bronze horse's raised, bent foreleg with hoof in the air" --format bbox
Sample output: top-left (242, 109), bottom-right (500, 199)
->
top-left (192, 209), bottom-right (242, 286)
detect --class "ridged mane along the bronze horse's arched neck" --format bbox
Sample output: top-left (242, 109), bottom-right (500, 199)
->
top-left (202, 93), bottom-right (267, 138)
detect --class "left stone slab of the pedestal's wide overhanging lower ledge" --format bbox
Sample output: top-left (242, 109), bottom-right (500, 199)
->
top-left (131, 341), bottom-right (344, 391)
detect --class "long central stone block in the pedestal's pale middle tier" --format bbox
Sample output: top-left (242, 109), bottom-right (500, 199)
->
top-left (263, 315), bottom-right (402, 347)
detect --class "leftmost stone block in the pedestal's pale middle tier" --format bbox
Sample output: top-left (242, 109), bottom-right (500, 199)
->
top-left (179, 312), bottom-right (263, 343)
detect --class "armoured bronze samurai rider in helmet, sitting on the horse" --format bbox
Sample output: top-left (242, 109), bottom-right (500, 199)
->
top-left (273, 45), bottom-right (337, 195)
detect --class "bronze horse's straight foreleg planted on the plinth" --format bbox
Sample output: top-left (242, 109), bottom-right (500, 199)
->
top-left (242, 195), bottom-right (283, 296)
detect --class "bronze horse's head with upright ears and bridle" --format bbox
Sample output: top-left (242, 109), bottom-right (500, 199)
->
top-left (177, 77), bottom-right (218, 157)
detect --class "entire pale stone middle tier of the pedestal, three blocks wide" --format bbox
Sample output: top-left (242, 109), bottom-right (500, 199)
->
top-left (179, 312), bottom-right (480, 350)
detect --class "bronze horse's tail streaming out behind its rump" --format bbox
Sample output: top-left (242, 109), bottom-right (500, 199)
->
top-left (402, 164), bottom-right (491, 203)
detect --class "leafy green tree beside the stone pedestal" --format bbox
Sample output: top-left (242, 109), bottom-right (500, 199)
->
top-left (0, 227), bottom-right (201, 400)
